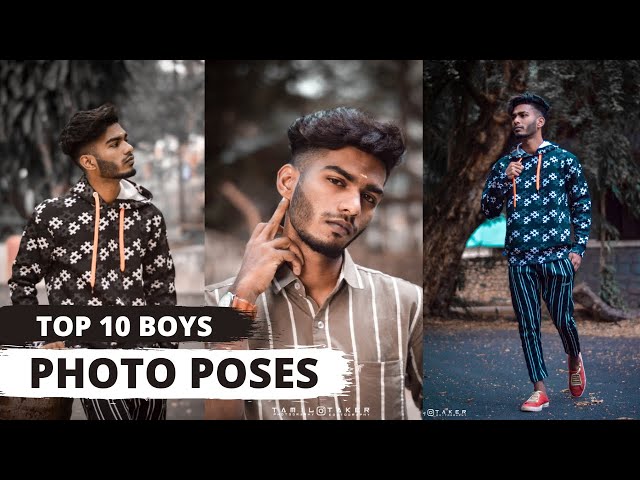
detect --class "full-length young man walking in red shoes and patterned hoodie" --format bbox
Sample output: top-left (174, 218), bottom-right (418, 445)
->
top-left (482, 93), bottom-right (591, 412)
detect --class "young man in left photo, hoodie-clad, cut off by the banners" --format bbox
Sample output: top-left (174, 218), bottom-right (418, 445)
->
top-left (9, 104), bottom-right (176, 420)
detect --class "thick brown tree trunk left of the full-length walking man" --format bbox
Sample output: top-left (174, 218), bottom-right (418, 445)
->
top-left (423, 61), bottom-right (528, 315)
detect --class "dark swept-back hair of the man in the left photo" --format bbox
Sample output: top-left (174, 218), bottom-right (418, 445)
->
top-left (60, 103), bottom-right (118, 162)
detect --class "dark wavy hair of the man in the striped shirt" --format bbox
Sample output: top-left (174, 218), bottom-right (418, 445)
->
top-left (287, 107), bottom-right (405, 178)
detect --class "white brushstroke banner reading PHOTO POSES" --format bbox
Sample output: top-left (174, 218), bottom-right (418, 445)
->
top-left (0, 348), bottom-right (353, 400)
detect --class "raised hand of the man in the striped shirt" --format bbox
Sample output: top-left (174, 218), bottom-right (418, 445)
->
top-left (229, 198), bottom-right (304, 303)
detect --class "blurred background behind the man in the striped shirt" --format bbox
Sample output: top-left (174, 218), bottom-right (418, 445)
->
top-left (205, 60), bottom-right (423, 284)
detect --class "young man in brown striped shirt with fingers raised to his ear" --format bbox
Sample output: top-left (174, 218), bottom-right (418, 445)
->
top-left (205, 107), bottom-right (423, 419)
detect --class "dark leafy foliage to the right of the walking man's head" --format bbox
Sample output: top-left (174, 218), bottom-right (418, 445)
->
top-left (529, 60), bottom-right (640, 219)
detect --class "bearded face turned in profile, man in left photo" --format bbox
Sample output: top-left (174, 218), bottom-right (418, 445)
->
top-left (92, 123), bottom-right (136, 179)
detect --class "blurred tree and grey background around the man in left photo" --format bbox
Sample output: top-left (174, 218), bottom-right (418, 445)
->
top-left (0, 60), bottom-right (205, 419)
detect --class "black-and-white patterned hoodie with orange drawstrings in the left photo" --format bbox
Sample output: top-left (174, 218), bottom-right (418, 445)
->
top-left (9, 176), bottom-right (176, 306)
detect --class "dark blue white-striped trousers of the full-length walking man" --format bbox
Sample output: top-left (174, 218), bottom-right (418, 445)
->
top-left (509, 258), bottom-right (580, 383)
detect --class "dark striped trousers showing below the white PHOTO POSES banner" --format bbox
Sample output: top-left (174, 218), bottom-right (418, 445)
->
top-left (82, 398), bottom-right (167, 420)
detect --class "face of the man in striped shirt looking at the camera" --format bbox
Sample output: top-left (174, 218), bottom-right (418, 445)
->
top-left (289, 147), bottom-right (386, 258)
